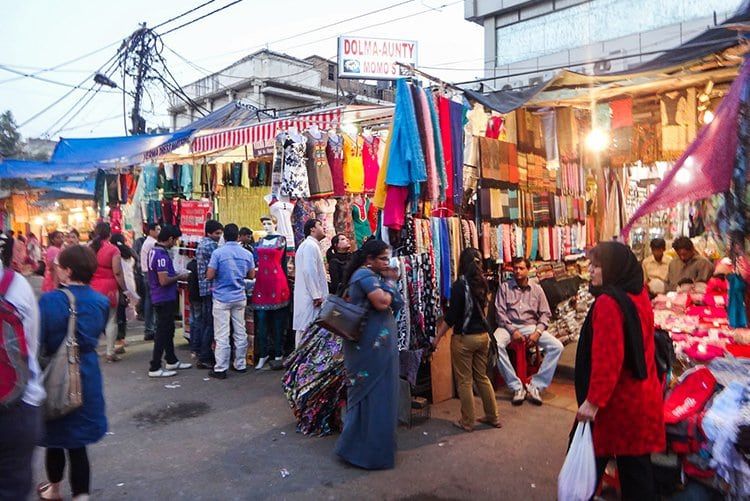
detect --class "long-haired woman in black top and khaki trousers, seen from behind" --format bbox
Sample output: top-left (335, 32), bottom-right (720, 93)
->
top-left (434, 248), bottom-right (501, 432)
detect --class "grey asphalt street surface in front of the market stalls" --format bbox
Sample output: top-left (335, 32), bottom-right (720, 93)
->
top-left (26, 323), bottom-right (574, 500)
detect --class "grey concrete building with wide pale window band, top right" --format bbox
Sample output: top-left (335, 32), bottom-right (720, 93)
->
top-left (464, 0), bottom-right (743, 90)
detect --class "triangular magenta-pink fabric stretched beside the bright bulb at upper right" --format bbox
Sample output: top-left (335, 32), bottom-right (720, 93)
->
top-left (622, 64), bottom-right (750, 238)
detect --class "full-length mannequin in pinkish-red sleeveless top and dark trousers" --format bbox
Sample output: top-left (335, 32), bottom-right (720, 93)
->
top-left (252, 216), bottom-right (290, 370)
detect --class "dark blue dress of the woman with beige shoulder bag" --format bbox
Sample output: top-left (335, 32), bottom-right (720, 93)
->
top-left (39, 285), bottom-right (109, 449)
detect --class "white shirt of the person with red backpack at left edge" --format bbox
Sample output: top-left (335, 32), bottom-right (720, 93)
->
top-left (0, 265), bottom-right (46, 407)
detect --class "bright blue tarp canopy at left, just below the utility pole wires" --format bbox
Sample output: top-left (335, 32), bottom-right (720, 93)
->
top-left (51, 129), bottom-right (193, 163)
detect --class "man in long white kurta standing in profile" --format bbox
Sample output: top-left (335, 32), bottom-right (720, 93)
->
top-left (292, 219), bottom-right (328, 347)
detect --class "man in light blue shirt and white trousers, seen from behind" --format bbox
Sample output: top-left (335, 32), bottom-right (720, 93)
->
top-left (206, 224), bottom-right (255, 379)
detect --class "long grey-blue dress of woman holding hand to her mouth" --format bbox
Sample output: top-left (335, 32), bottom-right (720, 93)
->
top-left (336, 268), bottom-right (403, 470)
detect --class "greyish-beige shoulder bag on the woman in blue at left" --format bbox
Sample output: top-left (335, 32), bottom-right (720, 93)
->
top-left (40, 288), bottom-right (83, 420)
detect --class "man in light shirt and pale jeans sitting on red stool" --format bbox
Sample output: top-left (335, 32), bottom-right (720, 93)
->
top-left (495, 258), bottom-right (563, 405)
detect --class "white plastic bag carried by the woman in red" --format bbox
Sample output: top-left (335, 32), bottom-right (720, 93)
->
top-left (557, 421), bottom-right (596, 501)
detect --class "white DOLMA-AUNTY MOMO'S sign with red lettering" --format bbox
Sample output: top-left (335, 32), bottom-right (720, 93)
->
top-left (338, 36), bottom-right (417, 80)
